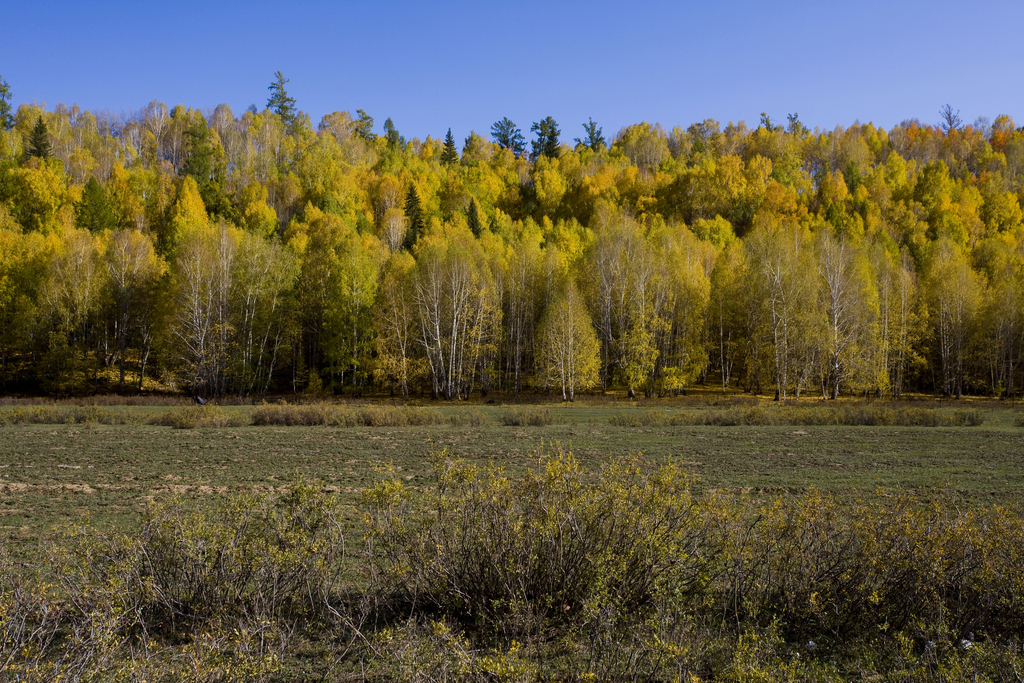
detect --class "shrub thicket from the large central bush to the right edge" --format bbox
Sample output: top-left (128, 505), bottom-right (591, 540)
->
top-left (365, 453), bottom-right (1024, 680)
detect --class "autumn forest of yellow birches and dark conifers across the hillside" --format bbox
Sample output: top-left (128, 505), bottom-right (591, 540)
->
top-left (0, 72), bottom-right (1024, 400)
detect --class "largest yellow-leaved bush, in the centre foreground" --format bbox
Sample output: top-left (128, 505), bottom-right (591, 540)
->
top-left (367, 452), bottom-right (702, 634)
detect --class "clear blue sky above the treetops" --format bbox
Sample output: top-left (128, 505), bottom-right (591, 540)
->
top-left (0, 0), bottom-right (1024, 140)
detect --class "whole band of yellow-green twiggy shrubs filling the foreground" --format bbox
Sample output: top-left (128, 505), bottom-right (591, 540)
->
top-left (0, 452), bottom-right (1024, 682)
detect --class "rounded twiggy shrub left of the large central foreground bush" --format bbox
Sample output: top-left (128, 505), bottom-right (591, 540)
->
top-left (139, 483), bottom-right (343, 621)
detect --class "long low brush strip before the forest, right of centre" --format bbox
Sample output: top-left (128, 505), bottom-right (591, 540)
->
top-left (608, 403), bottom-right (983, 427)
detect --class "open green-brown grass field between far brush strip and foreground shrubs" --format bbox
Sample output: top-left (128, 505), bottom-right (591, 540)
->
top-left (0, 401), bottom-right (1024, 554)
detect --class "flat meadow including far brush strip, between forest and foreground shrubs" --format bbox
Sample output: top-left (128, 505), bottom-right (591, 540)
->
top-left (0, 397), bottom-right (1024, 554)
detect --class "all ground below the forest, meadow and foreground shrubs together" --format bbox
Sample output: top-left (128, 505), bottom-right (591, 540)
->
top-left (6, 396), bottom-right (1024, 683)
